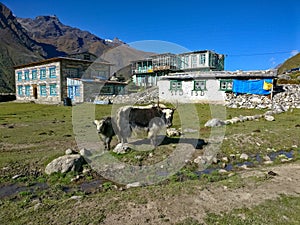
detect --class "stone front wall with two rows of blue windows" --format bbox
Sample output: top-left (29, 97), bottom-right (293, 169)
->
top-left (15, 62), bottom-right (62, 103)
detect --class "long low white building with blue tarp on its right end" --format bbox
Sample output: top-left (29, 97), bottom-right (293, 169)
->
top-left (158, 70), bottom-right (277, 103)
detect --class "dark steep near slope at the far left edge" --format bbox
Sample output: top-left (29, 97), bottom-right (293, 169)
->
top-left (0, 3), bottom-right (47, 93)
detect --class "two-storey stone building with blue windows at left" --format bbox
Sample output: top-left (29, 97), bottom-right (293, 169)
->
top-left (14, 53), bottom-right (111, 103)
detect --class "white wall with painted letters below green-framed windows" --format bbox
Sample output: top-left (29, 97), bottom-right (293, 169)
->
top-left (158, 78), bottom-right (226, 103)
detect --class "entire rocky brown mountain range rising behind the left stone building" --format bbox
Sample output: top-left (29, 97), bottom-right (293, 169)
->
top-left (0, 3), bottom-right (152, 93)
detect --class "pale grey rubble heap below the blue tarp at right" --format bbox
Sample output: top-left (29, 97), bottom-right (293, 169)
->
top-left (226, 84), bottom-right (300, 111)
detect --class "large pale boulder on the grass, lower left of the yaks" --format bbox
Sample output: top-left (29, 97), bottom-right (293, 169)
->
top-left (45, 154), bottom-right (85, 175)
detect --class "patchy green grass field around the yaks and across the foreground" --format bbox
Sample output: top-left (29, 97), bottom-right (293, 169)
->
top-left (0, 103), bottom-right (300, 224)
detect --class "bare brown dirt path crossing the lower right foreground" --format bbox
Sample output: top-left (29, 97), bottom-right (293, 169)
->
top-left (104, 162), bottom-right (300, 225)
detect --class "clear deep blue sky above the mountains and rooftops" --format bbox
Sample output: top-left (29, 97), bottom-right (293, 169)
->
top-left (2, 0), bottom-right (300, 70)
